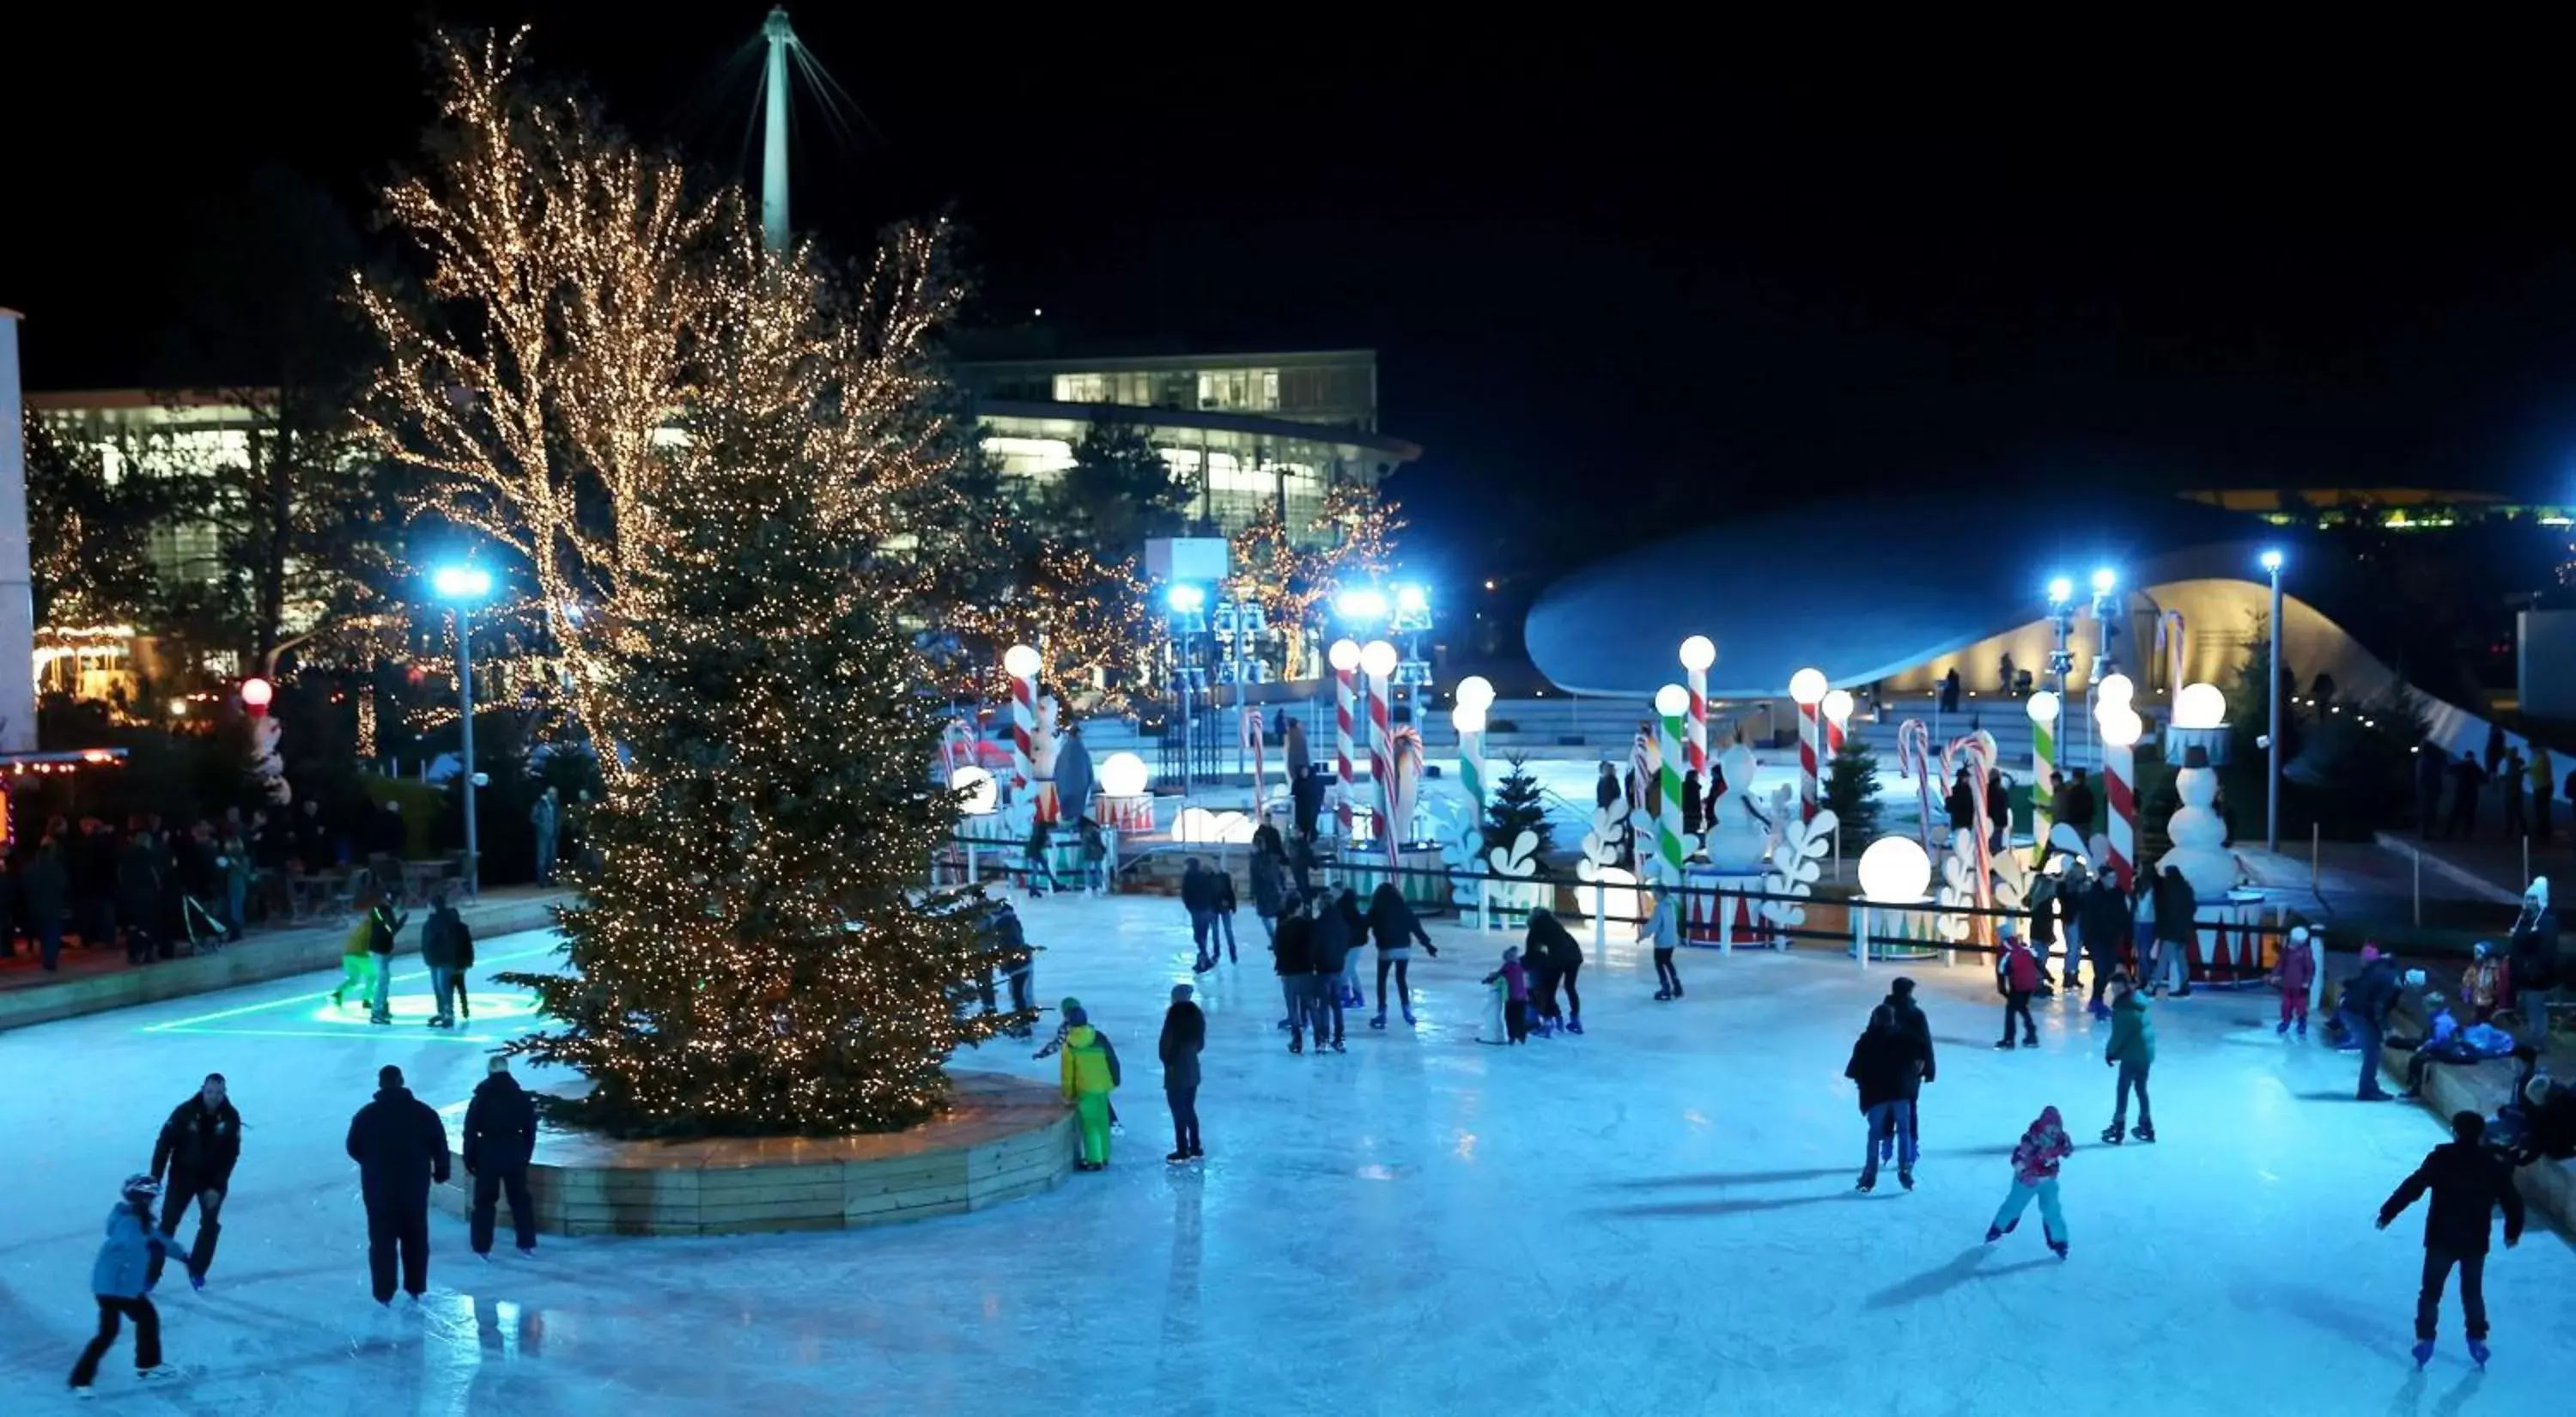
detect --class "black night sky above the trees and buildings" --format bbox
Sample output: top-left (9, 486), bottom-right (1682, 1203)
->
top-left (0, 14), bottom-right (2576, 598)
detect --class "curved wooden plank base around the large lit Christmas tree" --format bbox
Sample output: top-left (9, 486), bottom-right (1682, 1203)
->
top-left (438, 1072), bottom-right (1077, 1237)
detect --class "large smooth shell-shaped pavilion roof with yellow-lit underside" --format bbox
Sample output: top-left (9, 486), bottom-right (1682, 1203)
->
top-left (1525, 492), bottom-right (2473, 732)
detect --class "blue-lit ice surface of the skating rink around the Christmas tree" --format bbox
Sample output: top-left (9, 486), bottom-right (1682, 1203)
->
top-left (0, 899), bottom-right (2576, 1417)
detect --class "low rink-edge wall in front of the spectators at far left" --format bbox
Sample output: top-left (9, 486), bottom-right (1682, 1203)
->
top-left (0, 891), bottom-right (572, 1033)
